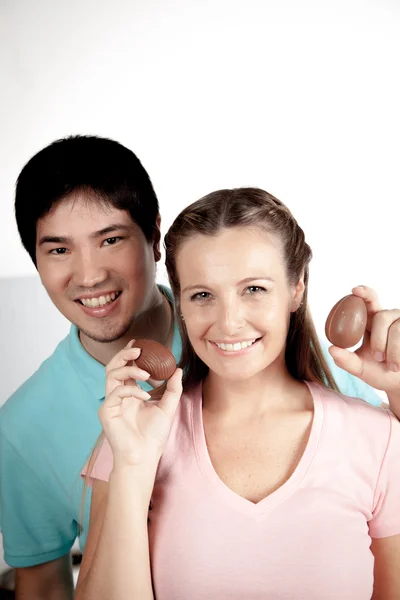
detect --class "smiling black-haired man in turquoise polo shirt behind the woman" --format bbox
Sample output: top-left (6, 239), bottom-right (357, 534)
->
top-left (0, 137), bottom-right (394, 600)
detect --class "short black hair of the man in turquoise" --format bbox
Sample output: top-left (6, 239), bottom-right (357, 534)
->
top-left (15, 135), bottom-right (159, 266)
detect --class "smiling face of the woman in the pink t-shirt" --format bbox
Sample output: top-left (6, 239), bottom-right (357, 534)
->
top-left (176, 227), bottom-right (304, 380)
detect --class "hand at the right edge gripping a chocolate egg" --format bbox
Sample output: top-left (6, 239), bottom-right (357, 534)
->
top-left (329, 286), bottom-right (400, 399)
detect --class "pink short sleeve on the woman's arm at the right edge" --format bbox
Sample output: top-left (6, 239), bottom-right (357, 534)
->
top-left (369, 411), bottom-right (400, 538)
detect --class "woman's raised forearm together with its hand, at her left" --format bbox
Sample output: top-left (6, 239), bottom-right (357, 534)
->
top-left (75, 345), bottom-right (182, 600)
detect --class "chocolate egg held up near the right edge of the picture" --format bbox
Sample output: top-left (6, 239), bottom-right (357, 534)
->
top-left (325, 294), bottom-right (367, 348)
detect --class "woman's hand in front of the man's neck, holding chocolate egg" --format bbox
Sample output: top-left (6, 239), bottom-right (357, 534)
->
top-left (99, 342), bottom-right (182, 467)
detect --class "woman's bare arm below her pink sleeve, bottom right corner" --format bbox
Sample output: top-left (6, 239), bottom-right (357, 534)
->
top-left (371, 535), bottom-right (400, 600)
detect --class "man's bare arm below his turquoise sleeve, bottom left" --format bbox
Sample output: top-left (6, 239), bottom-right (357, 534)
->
top-left (15, 554), bottom-right (74, 600)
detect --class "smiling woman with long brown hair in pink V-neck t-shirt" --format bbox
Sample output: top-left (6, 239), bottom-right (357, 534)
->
top-left (76, 188), bottom-right (400, 600)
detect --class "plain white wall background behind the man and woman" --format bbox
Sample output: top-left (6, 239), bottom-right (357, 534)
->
top-left (0, 0), bottom-right (400, 572)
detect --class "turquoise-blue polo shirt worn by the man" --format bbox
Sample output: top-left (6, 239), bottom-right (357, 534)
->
top-left (0, 326), bottom-right (380, 567)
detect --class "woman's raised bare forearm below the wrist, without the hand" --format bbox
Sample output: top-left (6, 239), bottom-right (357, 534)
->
top-left (75, 467), bottom-right (155, 600)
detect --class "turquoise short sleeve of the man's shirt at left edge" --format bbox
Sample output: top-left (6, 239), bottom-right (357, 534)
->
top-left (0, 431), bottom-right (77, 567)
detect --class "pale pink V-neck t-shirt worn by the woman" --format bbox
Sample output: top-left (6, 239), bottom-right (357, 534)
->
top-left (86, 384), bottom-right (400, 600)
